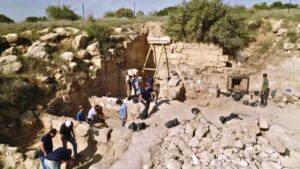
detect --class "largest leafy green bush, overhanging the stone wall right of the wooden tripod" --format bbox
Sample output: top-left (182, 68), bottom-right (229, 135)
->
top-left (165, 0), bottom-right (250, 52)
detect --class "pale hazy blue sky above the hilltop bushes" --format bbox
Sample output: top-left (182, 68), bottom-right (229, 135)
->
top-left (0, 0), bottom-right (300, 22)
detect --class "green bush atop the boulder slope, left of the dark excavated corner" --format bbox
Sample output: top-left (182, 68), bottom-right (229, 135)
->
top-left (86, 24), bottom-right (112, 47)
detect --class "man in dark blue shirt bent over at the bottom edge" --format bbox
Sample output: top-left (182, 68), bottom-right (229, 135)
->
top-left (45, 147), bottom-right (72, 169)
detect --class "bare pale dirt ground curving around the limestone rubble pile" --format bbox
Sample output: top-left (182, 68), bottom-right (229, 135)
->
top-left (91, 96), bottom-right (300, 169)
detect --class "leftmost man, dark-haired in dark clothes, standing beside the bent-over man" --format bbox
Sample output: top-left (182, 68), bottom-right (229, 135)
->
top-left (39, 129), bottom-right (57, 169)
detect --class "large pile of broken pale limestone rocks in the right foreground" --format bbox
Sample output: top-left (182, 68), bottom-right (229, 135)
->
top-left (152, 113), bottom-right (300, 169)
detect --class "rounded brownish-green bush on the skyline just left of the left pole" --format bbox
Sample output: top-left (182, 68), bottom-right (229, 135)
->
top-left (46, 5), bottom-right (80, 21)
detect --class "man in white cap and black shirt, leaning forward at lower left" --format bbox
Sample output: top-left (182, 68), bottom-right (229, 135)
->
top-left (59, 120), bottom-right (77, 158)
